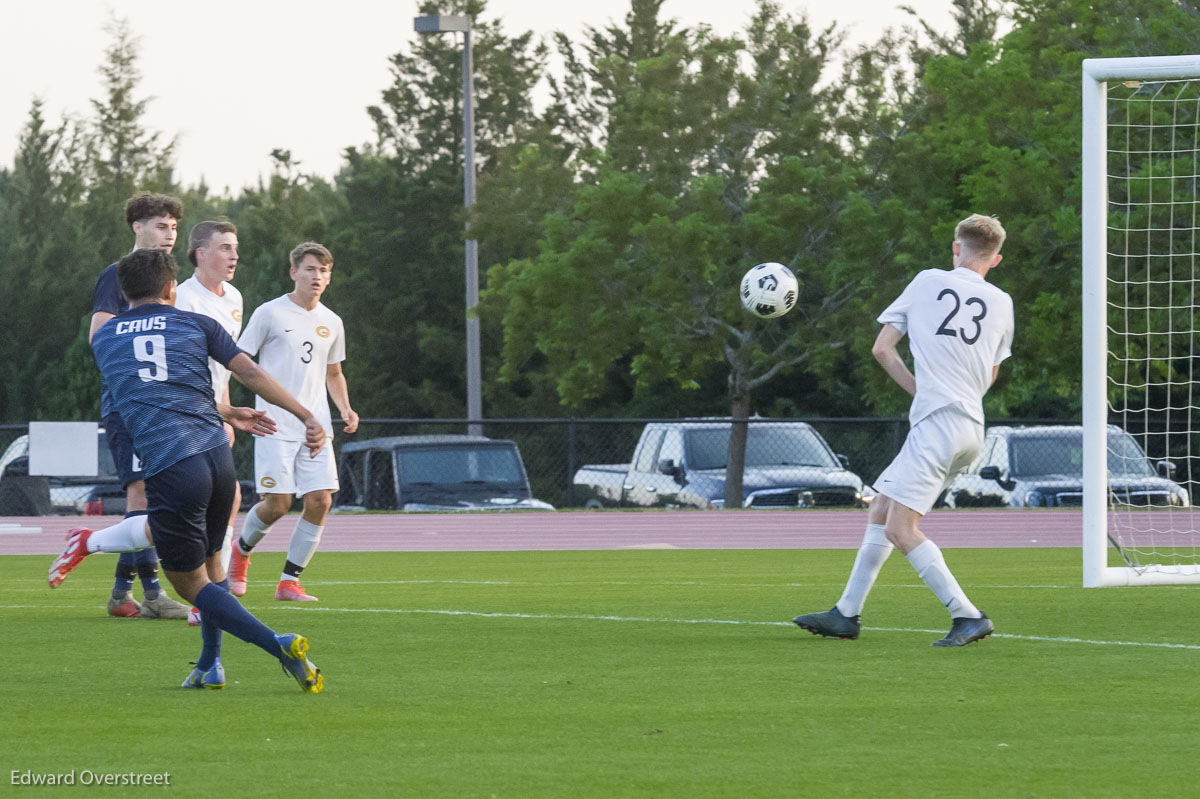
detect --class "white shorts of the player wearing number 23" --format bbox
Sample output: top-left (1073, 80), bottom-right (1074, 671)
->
top-left (875, 405), bottom-right (983, 516)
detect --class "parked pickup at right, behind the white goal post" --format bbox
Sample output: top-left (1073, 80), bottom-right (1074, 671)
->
top-left (943, 425), bottom-right (1190, 507)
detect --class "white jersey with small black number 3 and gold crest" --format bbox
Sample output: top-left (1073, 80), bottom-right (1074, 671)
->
top-left (238, 294), bottom-right (346, 441)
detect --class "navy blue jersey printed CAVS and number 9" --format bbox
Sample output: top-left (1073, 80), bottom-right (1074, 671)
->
top-left (91, 302), bottom-right (241, 477)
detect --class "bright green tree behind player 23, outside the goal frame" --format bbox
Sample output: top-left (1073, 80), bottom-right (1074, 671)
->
top-left (863, 0), bottom-right (1200, 416)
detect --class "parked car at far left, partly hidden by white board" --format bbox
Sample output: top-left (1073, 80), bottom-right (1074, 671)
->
top-left (0, 428), bottom-right (257, 516)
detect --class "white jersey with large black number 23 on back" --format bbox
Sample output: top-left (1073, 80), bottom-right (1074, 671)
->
top-left (878, 266), bottom-right (1013, 425)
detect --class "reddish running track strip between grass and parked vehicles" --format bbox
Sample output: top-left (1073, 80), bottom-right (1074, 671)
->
top-left (0, 509), bottom-right (1081, 555)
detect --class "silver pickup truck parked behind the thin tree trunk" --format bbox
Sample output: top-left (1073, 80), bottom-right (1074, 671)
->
top-left (574, 420), bottom-right (871, 507)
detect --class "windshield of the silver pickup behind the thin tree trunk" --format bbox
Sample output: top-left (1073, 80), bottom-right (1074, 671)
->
top-left (688, 425), bottom-right (841, 469)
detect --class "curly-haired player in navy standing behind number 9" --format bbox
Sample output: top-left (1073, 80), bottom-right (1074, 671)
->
top-left (88, 192), bottom-right (187, 619)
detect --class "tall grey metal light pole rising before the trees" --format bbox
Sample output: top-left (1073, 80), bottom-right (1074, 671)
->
top-left (413, 14), bottom-right (484, 435)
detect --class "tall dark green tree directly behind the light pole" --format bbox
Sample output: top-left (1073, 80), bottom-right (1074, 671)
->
top-left (331, 0), bottom-right (546, 417)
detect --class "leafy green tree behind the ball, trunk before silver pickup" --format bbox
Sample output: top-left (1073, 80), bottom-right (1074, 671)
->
top-left (487, 0), bottom-right (860, 507)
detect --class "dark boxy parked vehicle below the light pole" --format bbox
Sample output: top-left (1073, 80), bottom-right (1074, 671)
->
top-left (334, 435), bottom-right (554, 511)
